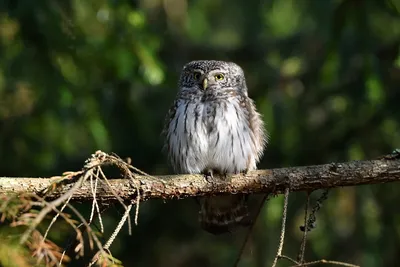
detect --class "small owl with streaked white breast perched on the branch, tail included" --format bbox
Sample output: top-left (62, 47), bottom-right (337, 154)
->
top-left (164, 60), bottom-right (267, 234)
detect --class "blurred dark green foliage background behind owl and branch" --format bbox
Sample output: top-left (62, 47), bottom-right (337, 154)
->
top-left (0, 0), bottom-right (400, 267)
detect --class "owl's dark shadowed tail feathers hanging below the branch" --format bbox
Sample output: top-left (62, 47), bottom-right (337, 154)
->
top-left (199, 194), bottom-right (251, 235)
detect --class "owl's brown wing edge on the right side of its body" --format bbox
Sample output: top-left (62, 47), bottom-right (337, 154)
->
top-left (244, 96), bottom-right (268, 161)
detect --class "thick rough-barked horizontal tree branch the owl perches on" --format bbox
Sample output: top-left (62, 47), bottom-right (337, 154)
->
top-left (0, 158), bottom-right (400, 201)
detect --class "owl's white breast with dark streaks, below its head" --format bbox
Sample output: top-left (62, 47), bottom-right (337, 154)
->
top-left (167, 92), bottom-right (257, 173)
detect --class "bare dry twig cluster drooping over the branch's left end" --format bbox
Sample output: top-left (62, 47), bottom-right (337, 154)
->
top-left (12, 151), bottom-right (147, 265)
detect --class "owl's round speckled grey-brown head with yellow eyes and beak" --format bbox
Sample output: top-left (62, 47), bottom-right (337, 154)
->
top-left (179, 60), bottom-right (247, 92)
